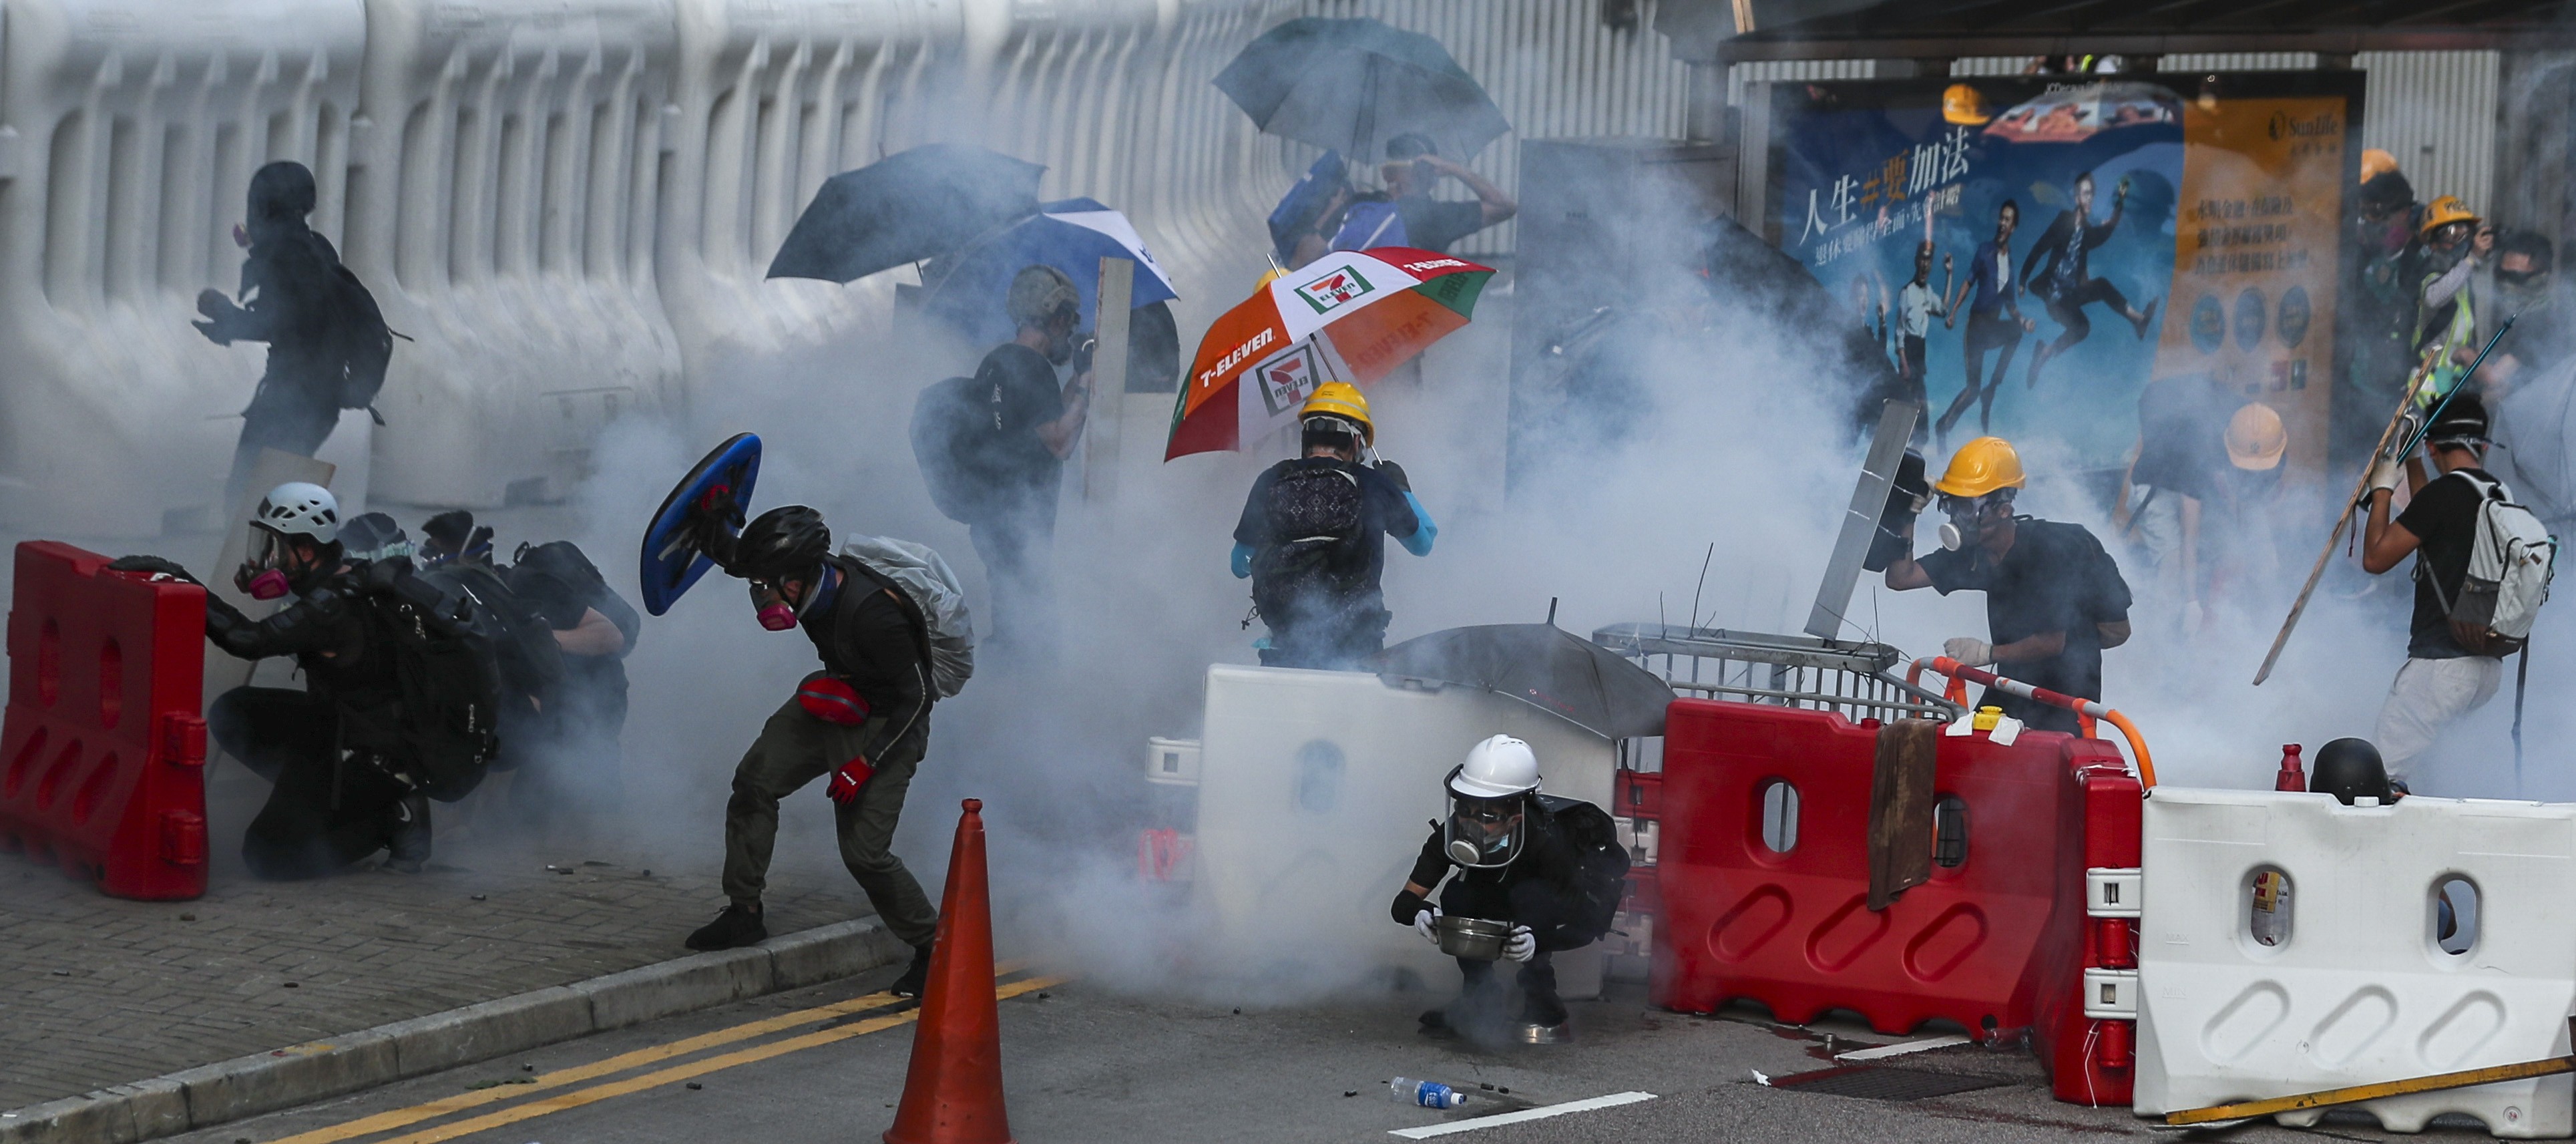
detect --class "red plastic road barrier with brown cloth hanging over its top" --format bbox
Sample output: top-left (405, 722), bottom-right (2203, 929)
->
top-left (1651, 699), bottom-right (2138, 1103)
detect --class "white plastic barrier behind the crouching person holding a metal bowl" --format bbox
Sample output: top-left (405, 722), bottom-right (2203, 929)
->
top-left (1193, 664), bottom-right (1618, 997)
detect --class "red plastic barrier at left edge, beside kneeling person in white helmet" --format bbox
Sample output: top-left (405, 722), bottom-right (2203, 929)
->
top-left (0, 541), bottom-right (206, 899)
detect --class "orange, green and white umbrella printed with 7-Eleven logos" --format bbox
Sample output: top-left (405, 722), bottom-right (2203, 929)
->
top-left (1162, 247), bottom-right (1494, 461)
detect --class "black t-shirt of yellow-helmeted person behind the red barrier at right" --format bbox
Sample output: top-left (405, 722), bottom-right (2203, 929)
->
top-left (1919, 516), bottom-right (2128, 732)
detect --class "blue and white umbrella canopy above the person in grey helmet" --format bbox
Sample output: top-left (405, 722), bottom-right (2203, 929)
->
top-left (922, 198), bottom-right (1180, 345)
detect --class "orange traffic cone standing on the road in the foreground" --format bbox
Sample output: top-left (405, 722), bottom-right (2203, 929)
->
top-left (886, 799), bottom-right (1012, 1144)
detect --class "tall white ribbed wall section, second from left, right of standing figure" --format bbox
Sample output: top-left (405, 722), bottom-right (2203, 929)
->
top-left (348, 0), bottom-right (680, 505)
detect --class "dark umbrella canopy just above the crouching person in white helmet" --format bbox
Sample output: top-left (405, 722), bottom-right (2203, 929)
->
top-left (1368, 624), bottom-right (1672, 739)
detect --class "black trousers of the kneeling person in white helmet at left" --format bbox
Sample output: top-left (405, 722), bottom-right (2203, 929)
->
top-left (206, 688), bottom-right (409, 881)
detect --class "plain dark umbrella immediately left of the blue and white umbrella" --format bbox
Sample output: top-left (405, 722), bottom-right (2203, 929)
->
top-left (771, 144), bottom-right (1046, 281)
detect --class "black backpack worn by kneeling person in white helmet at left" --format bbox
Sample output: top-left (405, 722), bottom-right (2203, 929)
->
top-left (358, 559), bottom-right (502, 801)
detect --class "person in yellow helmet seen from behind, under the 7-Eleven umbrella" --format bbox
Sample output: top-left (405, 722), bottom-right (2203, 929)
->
top-left (1234, 381), bottom-right (1440, 670)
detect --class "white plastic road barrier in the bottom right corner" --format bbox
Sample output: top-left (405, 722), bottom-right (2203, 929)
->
top-left (2135, 786), bottom-right (2576, 1139)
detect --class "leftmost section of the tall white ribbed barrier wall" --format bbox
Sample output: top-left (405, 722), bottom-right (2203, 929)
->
top-left (0, 0), bottom-right (366, 536)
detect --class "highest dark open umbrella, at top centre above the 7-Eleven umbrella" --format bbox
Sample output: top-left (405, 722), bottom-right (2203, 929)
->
top-left (1216, 15), bottom-right (1512, 162)
